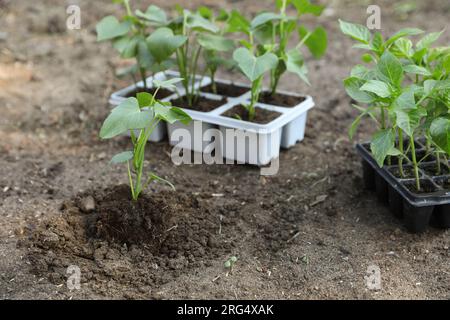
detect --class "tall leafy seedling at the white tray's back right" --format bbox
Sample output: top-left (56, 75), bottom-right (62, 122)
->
top-left (237, 0), bottom-right (327, 95)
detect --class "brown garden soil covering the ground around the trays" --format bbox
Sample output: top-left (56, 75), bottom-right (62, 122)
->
top-left (0, 0), bottom-right (450, 300)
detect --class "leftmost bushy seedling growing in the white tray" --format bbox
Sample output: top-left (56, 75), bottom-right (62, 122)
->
top-left (96, 0), bottom-right (187, 89)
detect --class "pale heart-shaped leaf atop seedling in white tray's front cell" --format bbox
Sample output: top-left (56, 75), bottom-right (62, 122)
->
top-left (233, 48), bottom-right (278, 82)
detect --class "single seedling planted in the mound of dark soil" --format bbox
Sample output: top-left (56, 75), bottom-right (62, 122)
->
top-left (100, 78), bottom-right (191, 201)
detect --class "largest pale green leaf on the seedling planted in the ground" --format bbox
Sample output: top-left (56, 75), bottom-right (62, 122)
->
top-left (100, 98), bottom-right (153, 139)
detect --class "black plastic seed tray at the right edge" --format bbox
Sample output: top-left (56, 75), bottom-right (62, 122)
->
top-left (356, 141), bottom-right (450, 233)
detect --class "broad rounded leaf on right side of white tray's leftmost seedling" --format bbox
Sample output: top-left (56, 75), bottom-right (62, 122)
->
top-left (147, 28), bottom-right (187, 63)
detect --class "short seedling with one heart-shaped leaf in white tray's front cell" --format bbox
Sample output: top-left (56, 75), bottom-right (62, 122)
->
top-left (233, 48), bottom-right (278, 121)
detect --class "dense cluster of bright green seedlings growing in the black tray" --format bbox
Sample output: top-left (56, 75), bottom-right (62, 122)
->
top-left (340, 21), bottom-right (450, 191)
